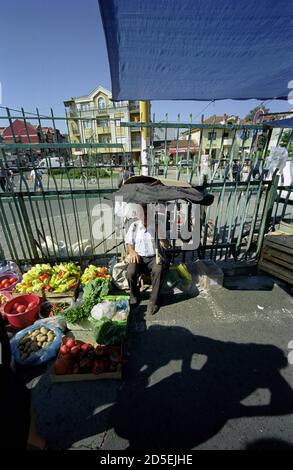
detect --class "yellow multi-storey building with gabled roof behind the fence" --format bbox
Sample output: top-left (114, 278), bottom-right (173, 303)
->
top-left (64, 86), bottom-right (150, 162)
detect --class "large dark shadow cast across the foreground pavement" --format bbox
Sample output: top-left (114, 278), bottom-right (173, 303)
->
top-left (34, 325), bottom-right (293, 450)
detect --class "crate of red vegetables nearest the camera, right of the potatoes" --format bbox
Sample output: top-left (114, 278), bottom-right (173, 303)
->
top-left (54, 336), bottom-right (122, 375)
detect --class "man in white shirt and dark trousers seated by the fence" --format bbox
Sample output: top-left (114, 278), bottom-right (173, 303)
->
top-left (125, 207), bottom-right (168, 315)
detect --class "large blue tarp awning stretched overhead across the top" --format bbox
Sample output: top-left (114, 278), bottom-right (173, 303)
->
top-left (99, 0), bottom-right (293, 100)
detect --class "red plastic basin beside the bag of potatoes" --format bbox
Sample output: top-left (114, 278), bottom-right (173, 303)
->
top-left (3, 294), bottom-right (40, 329)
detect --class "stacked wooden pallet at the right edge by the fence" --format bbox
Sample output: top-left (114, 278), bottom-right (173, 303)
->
top-left (258, 232), bottom-right (293, 285)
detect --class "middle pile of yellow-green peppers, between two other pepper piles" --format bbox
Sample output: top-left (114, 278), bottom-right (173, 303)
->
top-left (46, 263), bottom-right (80, 293)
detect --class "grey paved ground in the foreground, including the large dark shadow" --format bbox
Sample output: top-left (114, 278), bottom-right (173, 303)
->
top-left (25, 278), bottom-right (293, 451)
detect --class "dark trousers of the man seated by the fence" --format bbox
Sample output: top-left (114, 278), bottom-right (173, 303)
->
top-left (127, 256), bottom-right (164, 305)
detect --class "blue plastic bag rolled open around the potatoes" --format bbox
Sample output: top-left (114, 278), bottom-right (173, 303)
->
top-left (10, 320), bottom-right (62, 366)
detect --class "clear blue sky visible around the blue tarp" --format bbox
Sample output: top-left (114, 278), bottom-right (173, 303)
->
top-left (0, 0), bottom-right (290, 131)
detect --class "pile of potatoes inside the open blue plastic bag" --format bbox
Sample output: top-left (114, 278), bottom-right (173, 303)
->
top-left (18, 327), bottom-right (55, 360)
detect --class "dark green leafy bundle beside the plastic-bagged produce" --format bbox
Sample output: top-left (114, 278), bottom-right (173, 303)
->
top-left (63, 279), bottom-right (110, 323)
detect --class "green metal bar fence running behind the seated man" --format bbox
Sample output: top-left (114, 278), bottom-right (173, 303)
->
top-left (0, 109), bottom-right (293, 264)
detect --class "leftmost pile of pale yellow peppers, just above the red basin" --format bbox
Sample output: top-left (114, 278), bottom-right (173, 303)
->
top-left (15, 264), bottom-right (52, 294)
